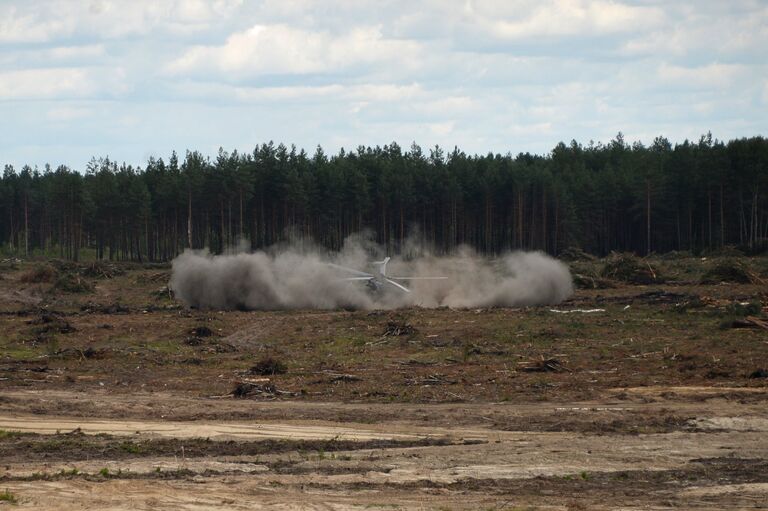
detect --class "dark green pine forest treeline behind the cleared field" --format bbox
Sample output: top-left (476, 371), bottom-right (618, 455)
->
top-left (0, 133), bottom-right (768, 261)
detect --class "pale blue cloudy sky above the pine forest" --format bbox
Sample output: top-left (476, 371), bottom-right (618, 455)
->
top-left (0, 0), bottom-right (768, 170)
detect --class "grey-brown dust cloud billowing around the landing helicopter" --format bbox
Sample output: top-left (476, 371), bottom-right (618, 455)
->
top-left (171, 236), bottom-right (573, 310)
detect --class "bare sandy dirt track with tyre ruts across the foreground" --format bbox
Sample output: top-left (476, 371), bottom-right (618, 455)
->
top-left (0, 388), bottom-right (768, 509)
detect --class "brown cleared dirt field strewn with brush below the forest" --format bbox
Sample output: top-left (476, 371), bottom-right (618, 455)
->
top-left (0, 257), bottom-right (768, 510)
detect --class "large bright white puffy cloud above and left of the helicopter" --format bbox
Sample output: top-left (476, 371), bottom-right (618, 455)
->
top-left (168, 25), bottom-right (421, 76)
